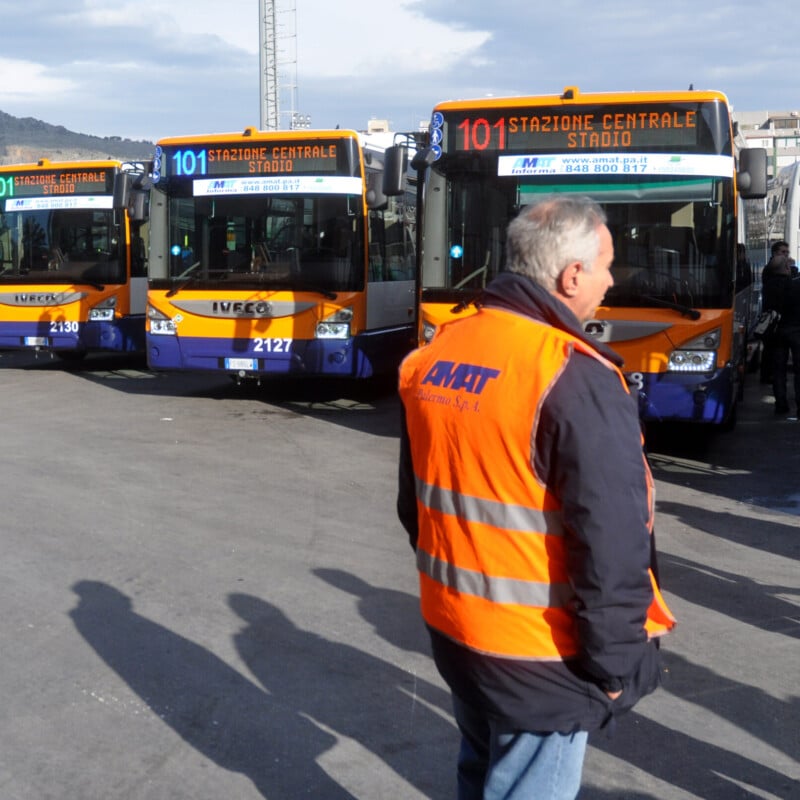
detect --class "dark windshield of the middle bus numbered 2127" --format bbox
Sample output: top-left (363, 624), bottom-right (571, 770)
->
top-left (159, 191), bottom-right (364, 292)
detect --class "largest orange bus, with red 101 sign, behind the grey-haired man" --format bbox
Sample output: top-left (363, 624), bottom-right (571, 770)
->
top-left (406, 87), bottom-right (766, 432)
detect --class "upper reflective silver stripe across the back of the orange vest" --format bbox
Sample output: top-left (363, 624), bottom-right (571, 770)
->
top-left (416, 478), bottom-right (564, 536)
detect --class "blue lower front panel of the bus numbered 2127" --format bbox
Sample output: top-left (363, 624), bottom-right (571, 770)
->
top-left (146, 328), bottom-right (413, 378)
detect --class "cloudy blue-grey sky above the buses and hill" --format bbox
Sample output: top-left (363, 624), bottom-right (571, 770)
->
top-left (0, 0), bottom-right (800, 141)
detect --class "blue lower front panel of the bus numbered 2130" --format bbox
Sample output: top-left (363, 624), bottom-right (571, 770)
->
top-left (0, 316), bottom-right (144, 353)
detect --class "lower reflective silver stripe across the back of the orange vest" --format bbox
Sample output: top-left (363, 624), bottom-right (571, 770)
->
top-left (417, 550), bottom-right (575, 608)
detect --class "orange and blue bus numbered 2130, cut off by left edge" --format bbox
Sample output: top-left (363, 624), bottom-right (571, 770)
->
top-left (0, 159), bottom-right (147, 358)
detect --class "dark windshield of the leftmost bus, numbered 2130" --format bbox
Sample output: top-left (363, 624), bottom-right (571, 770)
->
top-left (0, 209), bottom-right (126, 284)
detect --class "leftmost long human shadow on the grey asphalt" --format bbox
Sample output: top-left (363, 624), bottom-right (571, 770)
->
top-left (70, 581), bottom-right (355, 800)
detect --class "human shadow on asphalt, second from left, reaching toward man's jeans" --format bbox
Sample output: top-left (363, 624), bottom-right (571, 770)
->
top-left (229, 594), bottom-right (459, 800)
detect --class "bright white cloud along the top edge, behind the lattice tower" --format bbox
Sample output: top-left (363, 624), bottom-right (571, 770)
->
top-left (89, 0), bottom-right (491, 80)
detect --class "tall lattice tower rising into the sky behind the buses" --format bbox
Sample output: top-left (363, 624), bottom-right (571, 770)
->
top-left (258, 0), bottom-right (309, 131)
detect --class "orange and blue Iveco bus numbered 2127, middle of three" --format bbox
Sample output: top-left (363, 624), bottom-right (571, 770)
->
top-left (147, 128), bottom-right (416, 381)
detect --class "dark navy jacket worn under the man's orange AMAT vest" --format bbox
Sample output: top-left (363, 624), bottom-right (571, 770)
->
top-left (397, 273), bottom-right (659, 732)
